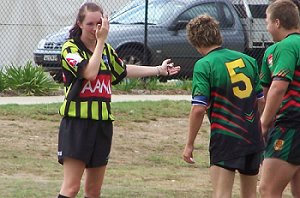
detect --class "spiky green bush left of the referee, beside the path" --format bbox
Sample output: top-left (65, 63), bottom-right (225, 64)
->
top-left (0, 61), bottom-right (59, 96)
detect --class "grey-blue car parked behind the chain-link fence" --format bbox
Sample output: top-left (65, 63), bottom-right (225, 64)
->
top-left (34, 0), bottom-right (265, 81)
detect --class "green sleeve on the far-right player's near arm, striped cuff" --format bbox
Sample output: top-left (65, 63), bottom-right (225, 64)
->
top-left (272, 43), bottom-right (297, 81)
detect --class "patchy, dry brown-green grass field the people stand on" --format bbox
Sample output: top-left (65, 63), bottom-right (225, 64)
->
top-left (0, 101), bottom-right (291, 198)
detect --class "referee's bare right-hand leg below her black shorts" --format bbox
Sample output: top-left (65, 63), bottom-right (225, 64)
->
top-left (84, 166), bottom-right (106, 198)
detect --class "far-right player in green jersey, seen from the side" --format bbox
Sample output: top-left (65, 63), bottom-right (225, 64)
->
top-left (259, 0), bottom-right (300, 198)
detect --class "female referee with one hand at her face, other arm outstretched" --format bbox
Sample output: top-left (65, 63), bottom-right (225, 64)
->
top-left (58, 2), bottom-right (180, 198)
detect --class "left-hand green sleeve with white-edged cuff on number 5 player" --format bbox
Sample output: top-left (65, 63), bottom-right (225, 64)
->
top-left (192, 60), bottom-right (210, 106)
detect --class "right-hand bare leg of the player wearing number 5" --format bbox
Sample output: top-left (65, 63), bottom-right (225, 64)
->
top-left (240, 174), bottom-right (258, 198)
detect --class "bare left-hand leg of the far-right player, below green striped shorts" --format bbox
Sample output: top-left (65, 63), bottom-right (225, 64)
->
top-left (259, 158), bottom-right (297, 198)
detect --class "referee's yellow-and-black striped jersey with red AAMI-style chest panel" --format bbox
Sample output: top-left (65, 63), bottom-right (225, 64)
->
top-left (59, 39), bottom-right (127, 120)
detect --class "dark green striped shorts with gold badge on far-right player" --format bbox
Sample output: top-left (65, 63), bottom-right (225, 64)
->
top-left (264, 126), bottom-right (300, 165)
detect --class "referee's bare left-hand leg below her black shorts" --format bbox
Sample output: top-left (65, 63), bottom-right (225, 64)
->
top-left (60, 158), bottom-right (85, 197)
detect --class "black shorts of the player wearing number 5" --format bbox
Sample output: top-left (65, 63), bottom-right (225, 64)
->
top-left (213, 152), bottom-right (263, 176)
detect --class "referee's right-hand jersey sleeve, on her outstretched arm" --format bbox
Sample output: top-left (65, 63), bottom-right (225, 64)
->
top-left (107, 44), bottom-right (127, 85)
